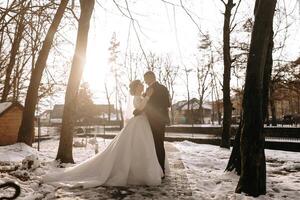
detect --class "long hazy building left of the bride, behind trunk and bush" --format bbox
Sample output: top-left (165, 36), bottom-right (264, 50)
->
top-left (50, 104), bottom-right (115, 124)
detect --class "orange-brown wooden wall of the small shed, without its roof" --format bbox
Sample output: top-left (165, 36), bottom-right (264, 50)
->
top-left (0, 106), bottom-right (22, 145)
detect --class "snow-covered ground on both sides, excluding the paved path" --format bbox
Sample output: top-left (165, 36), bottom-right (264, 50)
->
top-left (0, 138), bottom-right (300, 200)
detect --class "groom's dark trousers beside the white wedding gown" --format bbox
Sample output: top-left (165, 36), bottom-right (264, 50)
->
top-left (149, 120), bottom-right (166, 173)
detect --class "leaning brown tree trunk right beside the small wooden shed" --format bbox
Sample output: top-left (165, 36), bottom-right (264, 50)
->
top-left (18, 0), bottom-right (68, 146)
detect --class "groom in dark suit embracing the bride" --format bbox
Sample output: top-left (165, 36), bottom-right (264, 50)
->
top-left (134, 71), bottom-right (171, 173)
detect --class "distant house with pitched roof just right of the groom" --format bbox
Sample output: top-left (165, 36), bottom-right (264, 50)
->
top-left (172, 98), bottom-right (212, 124)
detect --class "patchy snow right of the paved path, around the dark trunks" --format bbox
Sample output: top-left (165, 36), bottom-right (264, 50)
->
top-left (174, 141), bottom-right (300, 200)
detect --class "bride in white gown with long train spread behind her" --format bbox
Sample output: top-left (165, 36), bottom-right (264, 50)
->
top-left (43, 80), bottom-right (168, 187)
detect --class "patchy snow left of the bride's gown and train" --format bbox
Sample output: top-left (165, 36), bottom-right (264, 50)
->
top-left (0, 138), bottom-right (111, 200)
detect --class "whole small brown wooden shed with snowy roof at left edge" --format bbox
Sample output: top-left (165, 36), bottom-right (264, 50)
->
top-left (0, 102), bottom-right (33, 145)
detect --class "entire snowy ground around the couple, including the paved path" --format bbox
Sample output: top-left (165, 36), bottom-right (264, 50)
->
top-left (0, 138), bottom-right (300, 200)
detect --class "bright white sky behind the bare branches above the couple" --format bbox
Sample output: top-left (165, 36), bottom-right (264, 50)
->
top-left (75, 0), bottom-right (300, 103)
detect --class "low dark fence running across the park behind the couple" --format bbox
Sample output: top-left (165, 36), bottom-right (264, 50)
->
top-left (34, 126), bottom-right (300, 152)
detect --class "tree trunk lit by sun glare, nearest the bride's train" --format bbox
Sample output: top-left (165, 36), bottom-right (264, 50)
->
top-left (56, 0), bottom-right (95, 163)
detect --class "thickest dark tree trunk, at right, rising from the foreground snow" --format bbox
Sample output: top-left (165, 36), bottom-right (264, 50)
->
top-left (236, 0), bottom-right (276, 197)
